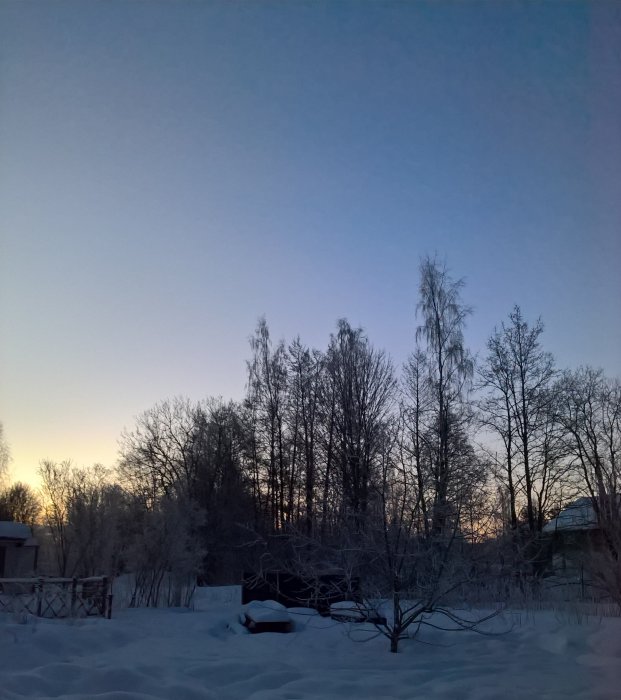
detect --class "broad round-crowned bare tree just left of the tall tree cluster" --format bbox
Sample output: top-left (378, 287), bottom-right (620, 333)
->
top-left (118, 398), bottom-right (252, 580)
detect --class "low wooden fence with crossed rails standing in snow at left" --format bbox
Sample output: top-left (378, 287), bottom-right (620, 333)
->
top-left (0, 576), bottom-right (112, 619)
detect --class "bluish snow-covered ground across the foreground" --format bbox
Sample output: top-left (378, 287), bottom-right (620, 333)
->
top-left (0, 587), bottom-right (621, 700)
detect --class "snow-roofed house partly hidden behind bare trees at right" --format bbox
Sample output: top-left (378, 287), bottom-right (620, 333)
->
top-left (542, 497), bottom-right (604, 574)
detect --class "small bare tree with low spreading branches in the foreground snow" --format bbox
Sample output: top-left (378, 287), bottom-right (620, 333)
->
top-left (278, 414), bottom-right (495, 653)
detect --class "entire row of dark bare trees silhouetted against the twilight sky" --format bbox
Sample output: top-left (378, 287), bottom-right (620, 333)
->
top-left (0, 258), bottom-right (621, 634)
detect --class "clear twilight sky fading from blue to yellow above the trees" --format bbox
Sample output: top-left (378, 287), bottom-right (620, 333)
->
top-left (0, 0), bottom-right (621, 483)
